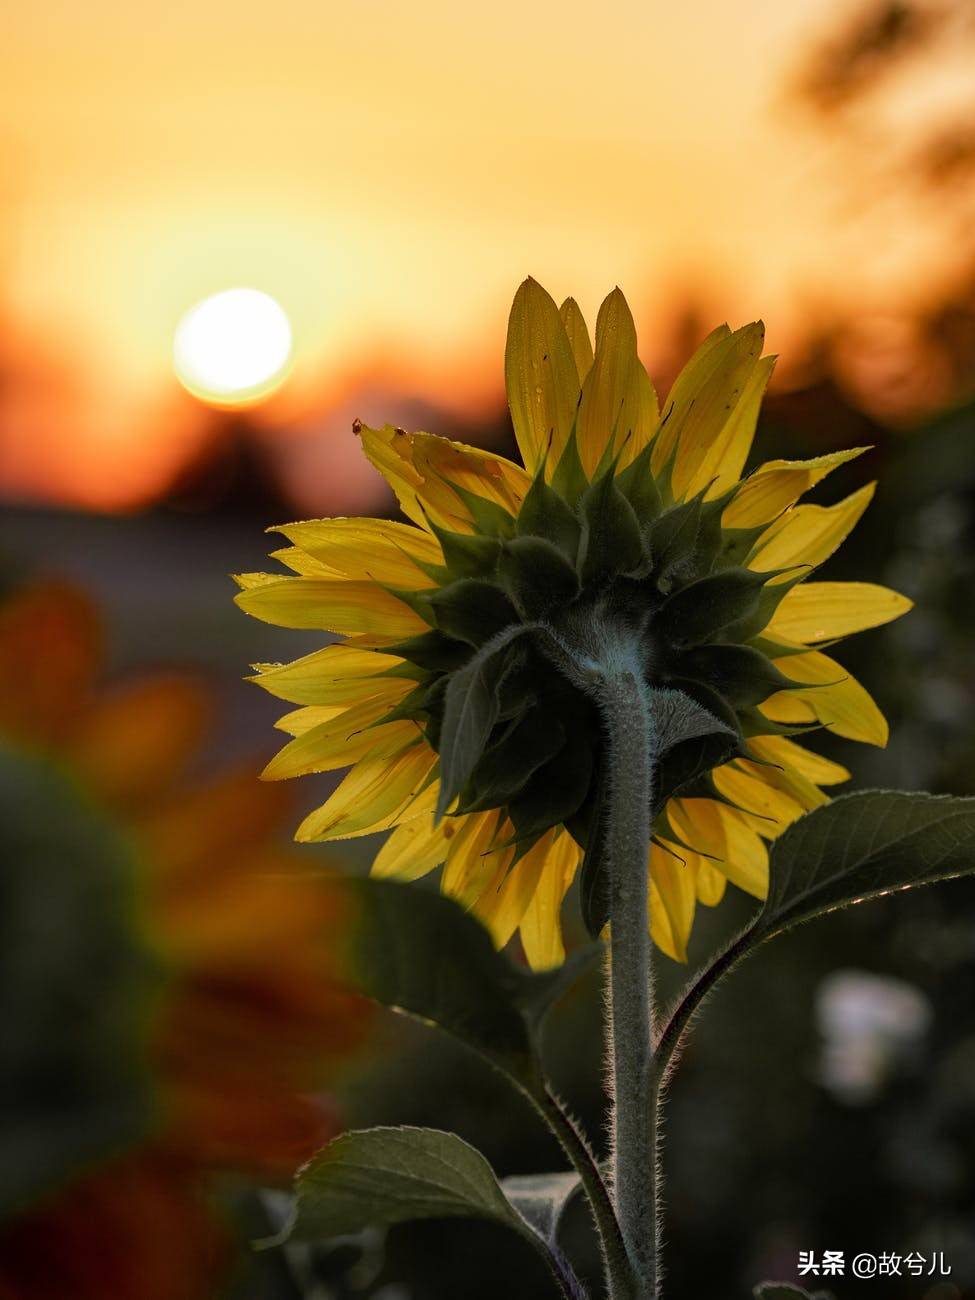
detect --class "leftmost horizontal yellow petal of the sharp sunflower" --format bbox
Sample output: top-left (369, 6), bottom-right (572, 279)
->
top-left (235, 573), bottom-right (429, 640)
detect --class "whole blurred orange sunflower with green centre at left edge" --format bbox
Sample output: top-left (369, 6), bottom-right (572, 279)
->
top-left (0, 582), bottom-right (365, 1300)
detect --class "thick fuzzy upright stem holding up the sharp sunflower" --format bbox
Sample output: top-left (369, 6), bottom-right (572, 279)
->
top-left (599, 655), bottom-right (659, 1300)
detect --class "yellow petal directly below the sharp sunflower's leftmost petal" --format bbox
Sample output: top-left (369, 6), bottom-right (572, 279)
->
top-left (248, 642), bottom-right (416, 705)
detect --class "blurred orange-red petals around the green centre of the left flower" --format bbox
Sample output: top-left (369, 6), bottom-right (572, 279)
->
top-left (0, 582), bottom-right (367, 1300)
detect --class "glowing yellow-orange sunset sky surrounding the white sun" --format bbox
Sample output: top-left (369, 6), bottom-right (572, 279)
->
top-left (0, 0), bottom-right (961, 504)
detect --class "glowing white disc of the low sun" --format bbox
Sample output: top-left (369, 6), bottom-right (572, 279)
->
top-left (173, 289), bottom-right (291, 406)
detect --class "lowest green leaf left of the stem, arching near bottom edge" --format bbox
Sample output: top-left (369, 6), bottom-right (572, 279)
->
top-left (263, 1127), bottom-right (582, 1297)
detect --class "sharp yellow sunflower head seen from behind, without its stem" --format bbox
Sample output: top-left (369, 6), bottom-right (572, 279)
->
top-left (237, 280), bottom-right (910, 967)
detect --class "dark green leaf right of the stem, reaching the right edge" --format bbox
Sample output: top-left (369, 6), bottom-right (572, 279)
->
top-left (751, 790), bottom-right (975, 941)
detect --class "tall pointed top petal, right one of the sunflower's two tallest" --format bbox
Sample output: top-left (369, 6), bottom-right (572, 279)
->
top-left (577, 289), bottom-right (659, 476)
